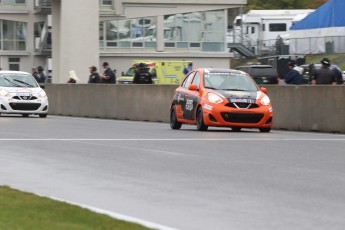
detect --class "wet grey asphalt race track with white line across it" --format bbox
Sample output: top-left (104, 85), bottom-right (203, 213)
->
top-left (0, 116), bottom-right (345, 230)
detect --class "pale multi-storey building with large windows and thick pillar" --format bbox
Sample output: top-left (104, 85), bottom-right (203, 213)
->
top-left (0, 0), bottom-right (247, 83)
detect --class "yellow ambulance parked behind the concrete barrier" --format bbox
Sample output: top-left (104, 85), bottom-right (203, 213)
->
top-left (117, 60), bottom-right (193, 84)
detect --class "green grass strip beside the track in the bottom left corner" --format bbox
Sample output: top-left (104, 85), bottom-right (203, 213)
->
top-left (0, 186), bottom-right (153, 230)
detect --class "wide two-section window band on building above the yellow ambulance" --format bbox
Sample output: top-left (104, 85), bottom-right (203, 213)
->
top-left (99, 10), bottom-right (227, 52)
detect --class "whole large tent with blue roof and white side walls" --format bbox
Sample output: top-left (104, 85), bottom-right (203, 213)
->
top-left (290, 0), bottom-right (345, 54)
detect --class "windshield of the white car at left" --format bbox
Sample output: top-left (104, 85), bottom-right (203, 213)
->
top-left (0, 73), bottom-right (39, 88)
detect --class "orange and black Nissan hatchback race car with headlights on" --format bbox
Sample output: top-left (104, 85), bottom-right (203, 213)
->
top-left (170, 68), bottom-right (273, 132)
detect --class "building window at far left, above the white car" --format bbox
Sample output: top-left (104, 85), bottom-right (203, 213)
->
top-left (0, 20), bottom-right (27, 50)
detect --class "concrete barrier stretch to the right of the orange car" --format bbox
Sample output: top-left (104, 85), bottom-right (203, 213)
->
top-left (267, 86), bottom-right (345, 133)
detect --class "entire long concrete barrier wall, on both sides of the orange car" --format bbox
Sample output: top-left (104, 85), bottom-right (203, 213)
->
top-left (46, 84), bottom-right (345, 133)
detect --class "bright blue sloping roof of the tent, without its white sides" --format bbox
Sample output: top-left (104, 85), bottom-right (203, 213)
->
top-left (290, 0), bottom-right (345, 30)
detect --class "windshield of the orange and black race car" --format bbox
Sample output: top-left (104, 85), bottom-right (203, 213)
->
top-left (204, 72), bottom-right (259, 91)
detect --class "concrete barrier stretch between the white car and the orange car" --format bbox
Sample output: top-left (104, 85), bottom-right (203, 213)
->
top-left (45, 84), bottom-right (176, 122)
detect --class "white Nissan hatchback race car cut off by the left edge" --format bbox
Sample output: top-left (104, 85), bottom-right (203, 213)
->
top-left (0, 71), bottom-right (48, 118)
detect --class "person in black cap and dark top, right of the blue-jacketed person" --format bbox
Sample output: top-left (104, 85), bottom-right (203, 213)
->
top-left (312, 58), bottom-right (336, 85)
